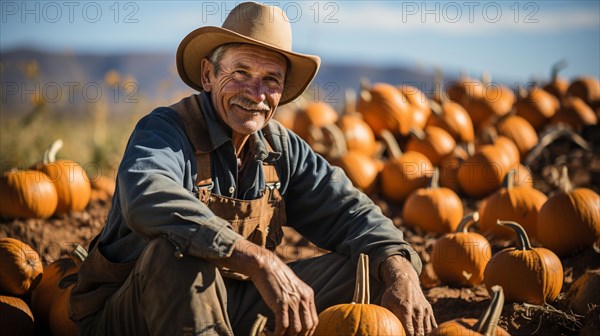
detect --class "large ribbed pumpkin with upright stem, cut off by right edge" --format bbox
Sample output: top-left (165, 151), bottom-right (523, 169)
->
top-left (537, 167), bottom-right (600, 256)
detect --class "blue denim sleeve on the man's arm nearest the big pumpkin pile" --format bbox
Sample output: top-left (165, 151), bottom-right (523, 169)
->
top-left (286, 133), bottom-right (422, 279)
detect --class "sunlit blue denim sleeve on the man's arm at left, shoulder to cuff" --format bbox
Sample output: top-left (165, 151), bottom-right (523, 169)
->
top-left (118, 113), bottom-right (242, 258)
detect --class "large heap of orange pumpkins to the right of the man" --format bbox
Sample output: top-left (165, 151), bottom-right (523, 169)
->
top-left (275, 71), bottom-right (600, 334)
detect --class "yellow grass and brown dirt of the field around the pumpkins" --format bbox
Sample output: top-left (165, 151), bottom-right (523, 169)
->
top-left (0, 64), bottom-right (600, 335)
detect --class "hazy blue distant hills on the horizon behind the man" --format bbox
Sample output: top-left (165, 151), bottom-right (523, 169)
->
top-left (0, 49), bottom-right (464, 112)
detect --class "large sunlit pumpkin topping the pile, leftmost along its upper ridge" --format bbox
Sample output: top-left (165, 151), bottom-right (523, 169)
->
top-left (357, 83), bottom-right (412, 136)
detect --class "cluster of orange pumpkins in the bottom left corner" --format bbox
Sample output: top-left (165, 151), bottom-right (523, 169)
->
top-left (0, 238), bottom-right (87, 336)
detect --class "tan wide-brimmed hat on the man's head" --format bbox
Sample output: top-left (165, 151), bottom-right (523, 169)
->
top-left (177, 2), bottom-right (321, 105)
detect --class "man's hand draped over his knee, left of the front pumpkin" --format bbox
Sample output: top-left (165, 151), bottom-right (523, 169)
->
top-left (217, 239), bottom-right (319, 335)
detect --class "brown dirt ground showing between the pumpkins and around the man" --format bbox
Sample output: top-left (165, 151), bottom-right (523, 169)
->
top-left (0, 128), bottom-right (600, 335)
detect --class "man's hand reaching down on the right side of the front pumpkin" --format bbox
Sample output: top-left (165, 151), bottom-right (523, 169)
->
top-left (380, 255), bottom-right (437, 335)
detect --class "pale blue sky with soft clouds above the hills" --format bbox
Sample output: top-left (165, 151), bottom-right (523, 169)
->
top-left (0, 0), bottom-right (600, 81)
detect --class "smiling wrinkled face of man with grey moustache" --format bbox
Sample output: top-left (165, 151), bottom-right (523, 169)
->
top-left (202, 44), bottom-right (286, 135)
